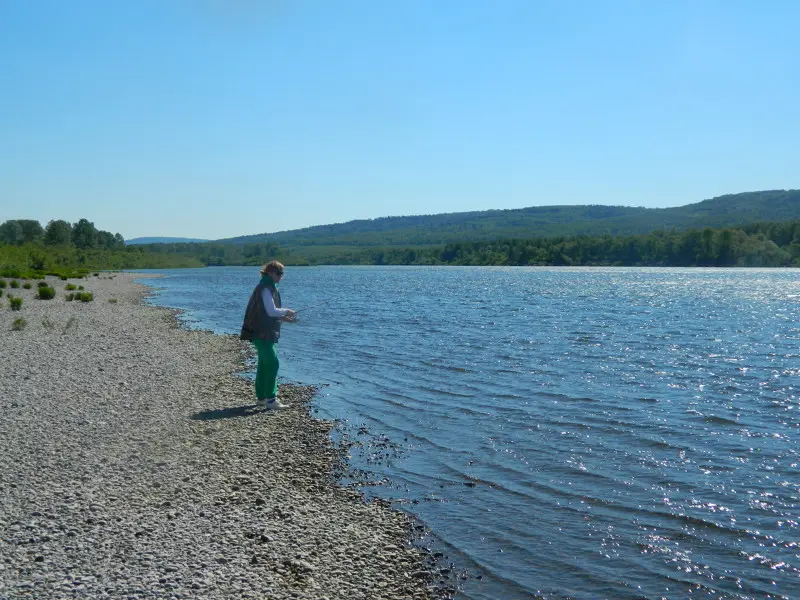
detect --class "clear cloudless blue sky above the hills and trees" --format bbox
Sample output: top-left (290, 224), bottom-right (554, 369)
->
top-left (0, 0), bottom-right (800, 239)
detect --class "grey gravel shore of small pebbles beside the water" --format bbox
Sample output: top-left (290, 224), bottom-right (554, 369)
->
top-left (0, 273), bottom-right (439, 600)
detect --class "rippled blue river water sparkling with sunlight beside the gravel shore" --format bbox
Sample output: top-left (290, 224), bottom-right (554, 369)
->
top-left (141, 267), bottom-right (800, 600)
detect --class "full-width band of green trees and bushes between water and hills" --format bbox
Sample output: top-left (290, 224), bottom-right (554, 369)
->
top-left (0, 219), bottom-right (800, 273)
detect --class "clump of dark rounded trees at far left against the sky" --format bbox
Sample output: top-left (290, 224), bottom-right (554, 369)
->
top-left (0, 219), bottom-right (125, 250)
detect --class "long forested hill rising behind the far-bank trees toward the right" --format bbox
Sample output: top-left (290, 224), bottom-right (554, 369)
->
top-left (218, 190), bottom-right (800, 248)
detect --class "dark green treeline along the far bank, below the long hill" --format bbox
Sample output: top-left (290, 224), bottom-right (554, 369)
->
top-left (304, 221), bottom-right (800, 267)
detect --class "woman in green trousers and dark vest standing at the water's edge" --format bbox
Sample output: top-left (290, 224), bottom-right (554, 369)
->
top-left (239, 260), bottom-right (296, 410)
